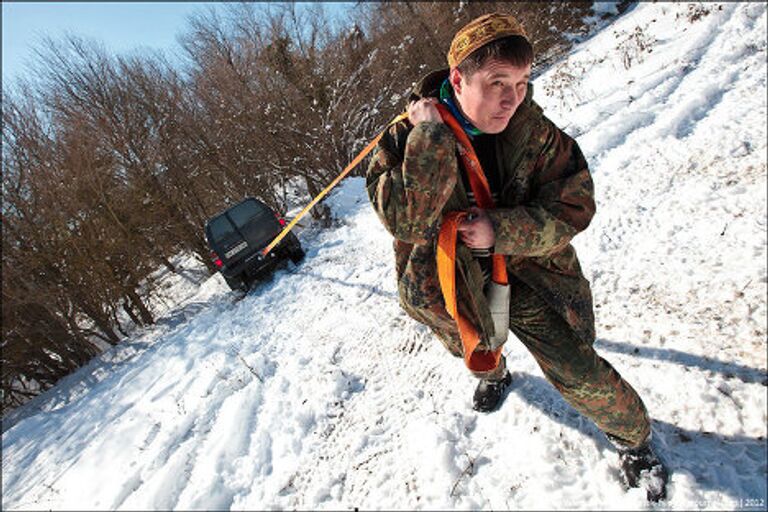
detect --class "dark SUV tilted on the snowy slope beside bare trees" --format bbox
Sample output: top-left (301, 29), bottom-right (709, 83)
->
top-left (205, 197), bottom-right (304, 291)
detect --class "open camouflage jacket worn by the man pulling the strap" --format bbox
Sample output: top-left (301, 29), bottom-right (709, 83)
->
top-left (366, 70), bottom-right (595, 356)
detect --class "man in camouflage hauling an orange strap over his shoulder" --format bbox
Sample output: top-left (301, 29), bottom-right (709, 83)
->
top-left (366, 13), bottom-right (667, 501)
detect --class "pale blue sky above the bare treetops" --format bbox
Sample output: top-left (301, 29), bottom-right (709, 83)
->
top-left (2, 1), bottom-right (353, 82)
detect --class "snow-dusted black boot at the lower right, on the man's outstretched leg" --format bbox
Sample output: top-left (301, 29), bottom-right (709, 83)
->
top-left (616, 438), bottom-right (669, 502)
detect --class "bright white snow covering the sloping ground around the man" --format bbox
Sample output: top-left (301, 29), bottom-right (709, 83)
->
top-left (2, 3), bottom-right (767, 510)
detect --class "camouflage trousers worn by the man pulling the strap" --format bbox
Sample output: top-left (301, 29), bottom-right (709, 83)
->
top-left (460, 278), bottom-right (650, 446)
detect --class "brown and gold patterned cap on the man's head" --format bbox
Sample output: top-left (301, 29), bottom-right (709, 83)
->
top-left (448, 12), bottom-right (528, 68)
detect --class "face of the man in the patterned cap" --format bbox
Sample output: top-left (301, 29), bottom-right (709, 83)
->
top-left (450, 59), bottom-right (531, 133)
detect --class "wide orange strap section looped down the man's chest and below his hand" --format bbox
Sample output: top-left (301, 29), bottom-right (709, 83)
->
top-left (436, 104), bottom-right (508, 372)
